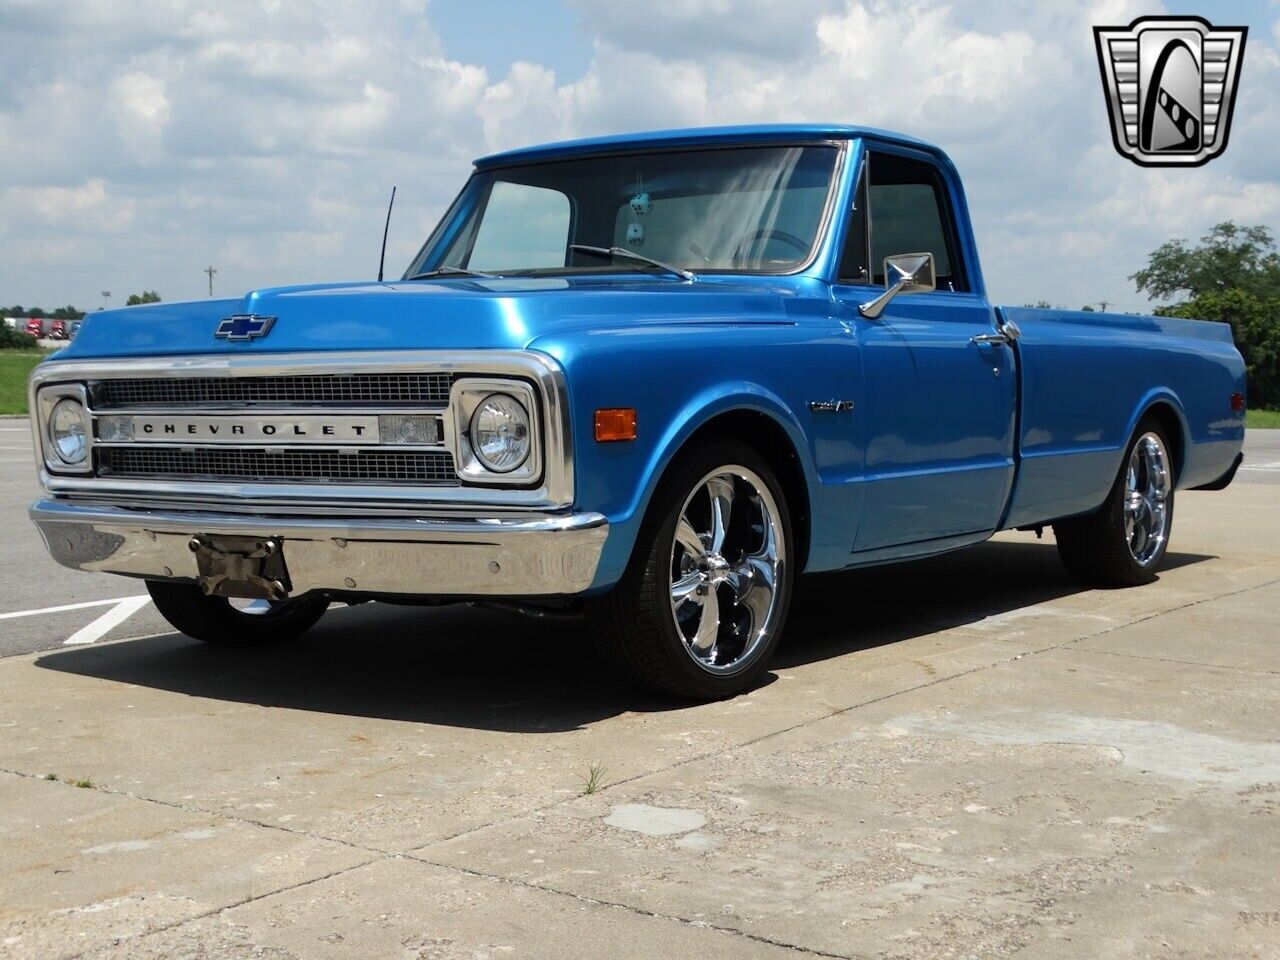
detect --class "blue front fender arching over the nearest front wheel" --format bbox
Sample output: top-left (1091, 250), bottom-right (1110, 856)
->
top-left (535, 324), bottom-right (861, 591)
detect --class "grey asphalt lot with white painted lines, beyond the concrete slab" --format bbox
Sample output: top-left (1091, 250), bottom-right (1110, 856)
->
top-left (0, 419), bottom-right (1280, 657)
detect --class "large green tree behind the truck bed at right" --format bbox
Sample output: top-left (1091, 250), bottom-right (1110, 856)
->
top-left (1129, 220), bottom-right (1280, 407)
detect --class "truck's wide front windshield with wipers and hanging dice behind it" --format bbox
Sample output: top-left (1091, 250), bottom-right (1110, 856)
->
top-left (406, 145), bottom-right (837, 278)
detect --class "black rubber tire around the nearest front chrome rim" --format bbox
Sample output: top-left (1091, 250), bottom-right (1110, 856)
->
top-left (586, 440), bottom-right (796, 701)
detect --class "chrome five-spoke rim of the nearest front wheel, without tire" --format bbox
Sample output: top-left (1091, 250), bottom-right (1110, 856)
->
top-left (671, 466), bottom-right (786, 673)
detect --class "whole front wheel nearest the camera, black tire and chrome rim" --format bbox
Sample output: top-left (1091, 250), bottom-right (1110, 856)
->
top-left (588, 440), bottom-right (794, 700)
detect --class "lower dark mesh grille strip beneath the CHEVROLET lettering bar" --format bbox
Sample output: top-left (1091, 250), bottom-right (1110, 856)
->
top-left (97, 445), bottom-right (458, 486)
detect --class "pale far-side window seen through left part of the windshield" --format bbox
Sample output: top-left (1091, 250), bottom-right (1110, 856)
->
top-left (466, 180), bottom-right (571, 271)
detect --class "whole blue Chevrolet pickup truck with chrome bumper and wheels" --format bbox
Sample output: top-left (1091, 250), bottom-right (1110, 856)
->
top-left (31, 125), bottom-right (1244, 699)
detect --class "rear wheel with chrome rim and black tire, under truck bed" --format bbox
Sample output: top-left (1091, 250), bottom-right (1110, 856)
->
top-left (1053, 417), bottom-right (1174, 586)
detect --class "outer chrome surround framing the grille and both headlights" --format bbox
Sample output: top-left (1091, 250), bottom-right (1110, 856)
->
top-left (28, 351), bottom-right (573, 509)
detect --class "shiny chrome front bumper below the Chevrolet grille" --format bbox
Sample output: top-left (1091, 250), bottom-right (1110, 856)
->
top-left (31, 499), bottom-right (609, 596)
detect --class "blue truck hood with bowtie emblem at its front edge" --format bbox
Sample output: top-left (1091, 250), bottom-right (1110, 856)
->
top-left (58, 275), bottom-right (827, 360)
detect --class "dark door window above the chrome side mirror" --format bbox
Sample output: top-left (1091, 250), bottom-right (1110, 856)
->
top-left (870, 154), bottom-right (969, 291)
